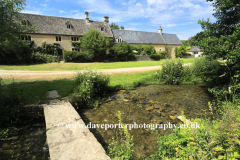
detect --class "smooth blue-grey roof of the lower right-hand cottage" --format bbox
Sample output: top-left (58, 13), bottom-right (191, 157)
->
top-left (112, 29), bottom-right (182, 45)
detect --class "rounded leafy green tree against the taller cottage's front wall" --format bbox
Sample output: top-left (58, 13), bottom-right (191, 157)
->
top-left (80, 28), bottom-right (110, 58)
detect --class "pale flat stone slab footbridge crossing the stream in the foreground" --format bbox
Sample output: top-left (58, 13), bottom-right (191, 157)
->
top-left (44, 102), bottom-right (111, 160)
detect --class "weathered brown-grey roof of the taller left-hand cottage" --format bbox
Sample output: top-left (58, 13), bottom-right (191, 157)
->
top-left (19, 13), bottom-right (113, 37)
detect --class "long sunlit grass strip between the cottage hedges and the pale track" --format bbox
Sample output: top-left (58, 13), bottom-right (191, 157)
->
top-left (0, 58), bottom-right (194, 71)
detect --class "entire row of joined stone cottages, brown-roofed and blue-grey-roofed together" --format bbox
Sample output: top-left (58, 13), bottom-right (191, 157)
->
top-left (19, 12), bottom-right (182, 58)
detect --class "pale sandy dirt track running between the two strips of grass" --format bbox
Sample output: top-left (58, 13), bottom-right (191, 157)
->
top-left (0, 63), bottom-right (191, 80)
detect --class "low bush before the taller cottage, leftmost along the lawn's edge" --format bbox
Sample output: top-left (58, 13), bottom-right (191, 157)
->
top-left (32, 53), bottom-right (56, 63)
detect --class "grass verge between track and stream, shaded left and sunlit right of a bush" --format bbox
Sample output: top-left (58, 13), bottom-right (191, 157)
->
top-left (2, 71), bottom-right (157, 104)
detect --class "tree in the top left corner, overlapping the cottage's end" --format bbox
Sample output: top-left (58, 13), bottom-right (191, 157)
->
top-left (0, 0), bottom-right (35, 45)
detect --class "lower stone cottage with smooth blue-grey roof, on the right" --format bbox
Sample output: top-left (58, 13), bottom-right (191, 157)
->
top-left (112, 26), bottom-right (182, 58)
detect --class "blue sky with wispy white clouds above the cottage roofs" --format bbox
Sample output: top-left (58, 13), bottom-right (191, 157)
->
top-left (22, 0), bottom-right (215, 40)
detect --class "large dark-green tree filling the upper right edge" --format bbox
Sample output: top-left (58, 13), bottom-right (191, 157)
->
top-left (199, 0), bottom-right (240, 82)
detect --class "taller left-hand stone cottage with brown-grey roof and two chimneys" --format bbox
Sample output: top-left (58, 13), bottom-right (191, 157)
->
top-left (19, 12), bottom-right (113, 56)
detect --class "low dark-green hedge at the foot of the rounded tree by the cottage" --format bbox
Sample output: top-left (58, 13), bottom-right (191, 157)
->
top-left (64, 51), bottom-right (93, 62)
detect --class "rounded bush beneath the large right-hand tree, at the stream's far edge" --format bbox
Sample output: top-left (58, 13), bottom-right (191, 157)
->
top-left (192, 57), bottom-right (228, 84)
